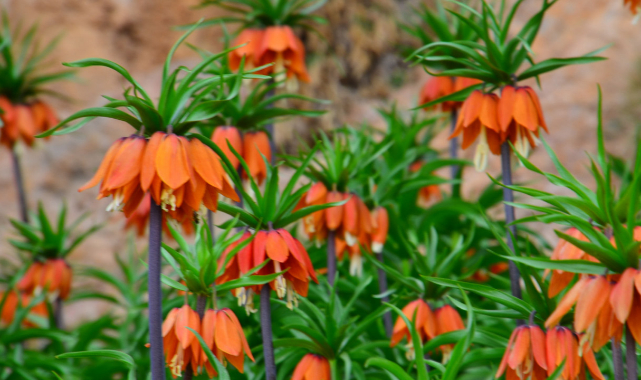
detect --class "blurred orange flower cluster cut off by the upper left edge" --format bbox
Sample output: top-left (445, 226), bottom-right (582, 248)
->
top-left (0, 96), bottom-right (58, 148)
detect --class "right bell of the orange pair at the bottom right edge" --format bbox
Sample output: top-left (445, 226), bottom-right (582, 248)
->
top-left (541, 326), bottom-right (605, 380)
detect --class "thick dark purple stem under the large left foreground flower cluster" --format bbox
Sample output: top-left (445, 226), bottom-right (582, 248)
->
top-left (148, 198), bottom-right (165, 380)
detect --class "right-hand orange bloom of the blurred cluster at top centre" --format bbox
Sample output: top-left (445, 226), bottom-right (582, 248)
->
top-left (256, 25), bottom-right (310, 86)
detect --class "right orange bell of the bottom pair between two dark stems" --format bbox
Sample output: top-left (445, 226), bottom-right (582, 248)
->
top-left (200, 308), bottom-right (255, 377)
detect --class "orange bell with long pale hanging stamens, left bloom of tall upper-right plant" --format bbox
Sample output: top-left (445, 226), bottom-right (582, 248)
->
top-left (450, 90), bottom-right (502, 171)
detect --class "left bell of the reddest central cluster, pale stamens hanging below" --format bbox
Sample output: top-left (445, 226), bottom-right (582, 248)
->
top-left (216, 231), bottom-right (260, 315)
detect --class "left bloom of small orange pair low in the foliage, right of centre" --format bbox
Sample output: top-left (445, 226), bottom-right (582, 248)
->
top-left (390, 299), bottom-right (437, 360)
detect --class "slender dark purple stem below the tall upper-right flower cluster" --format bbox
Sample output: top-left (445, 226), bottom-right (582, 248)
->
top-left (501, 141), bottom-right (523, 306)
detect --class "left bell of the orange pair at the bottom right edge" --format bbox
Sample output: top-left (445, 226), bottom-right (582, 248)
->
top-left (496, 325), bottom-right (548, 380)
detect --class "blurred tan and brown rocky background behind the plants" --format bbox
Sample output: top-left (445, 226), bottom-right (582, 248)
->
top-left (0, 0), bottom-right (641, 319)
